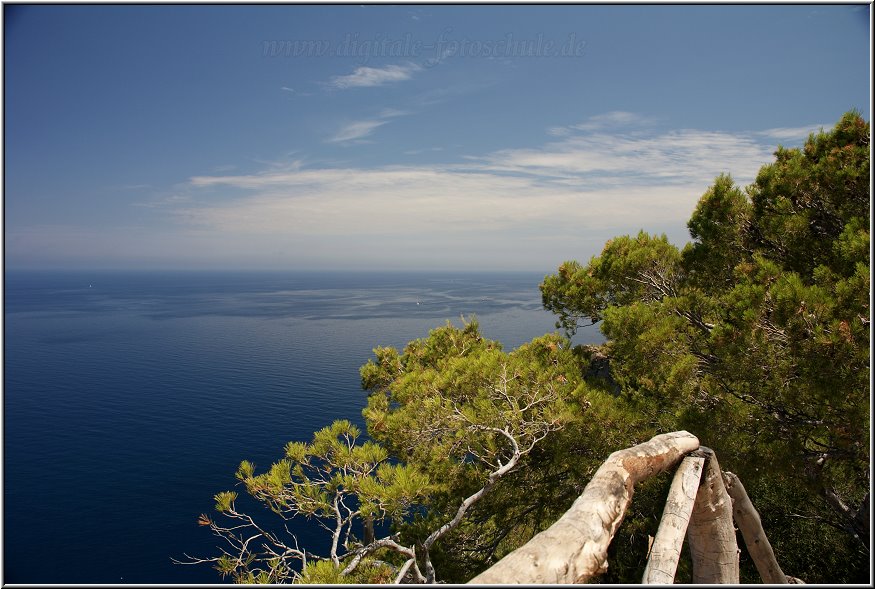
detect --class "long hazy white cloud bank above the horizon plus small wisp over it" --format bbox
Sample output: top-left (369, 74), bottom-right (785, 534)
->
top-left (130, 113), bottom-right (820, 267)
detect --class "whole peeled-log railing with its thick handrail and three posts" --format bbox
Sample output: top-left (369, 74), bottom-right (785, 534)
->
top-left (469, 431), bottom-right (799, 585)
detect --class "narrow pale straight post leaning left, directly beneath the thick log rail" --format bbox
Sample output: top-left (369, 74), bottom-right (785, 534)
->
top-left (641, 456), bottom-right (705, 584)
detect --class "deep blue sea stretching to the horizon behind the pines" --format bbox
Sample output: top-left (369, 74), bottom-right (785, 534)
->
top-left (3, 272), bottom-right (601, 584)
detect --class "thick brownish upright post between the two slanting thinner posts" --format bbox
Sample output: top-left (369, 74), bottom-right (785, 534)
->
top-left (687, 446), bottom-right (739, 584)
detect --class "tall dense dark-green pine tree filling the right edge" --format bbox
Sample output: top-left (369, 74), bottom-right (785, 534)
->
top-left (541, 112), bottom-right (870, 582)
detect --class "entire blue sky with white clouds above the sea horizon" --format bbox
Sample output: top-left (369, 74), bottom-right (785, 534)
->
top-left (4, 4), bottom-right (871, 272)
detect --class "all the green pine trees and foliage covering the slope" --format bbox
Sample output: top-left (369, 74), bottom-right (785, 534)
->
top-left (185, 113), bottom-right (870, 583)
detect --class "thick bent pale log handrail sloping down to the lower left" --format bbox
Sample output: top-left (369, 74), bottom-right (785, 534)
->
top-left (469, 431), bottom-right (699, 584)
